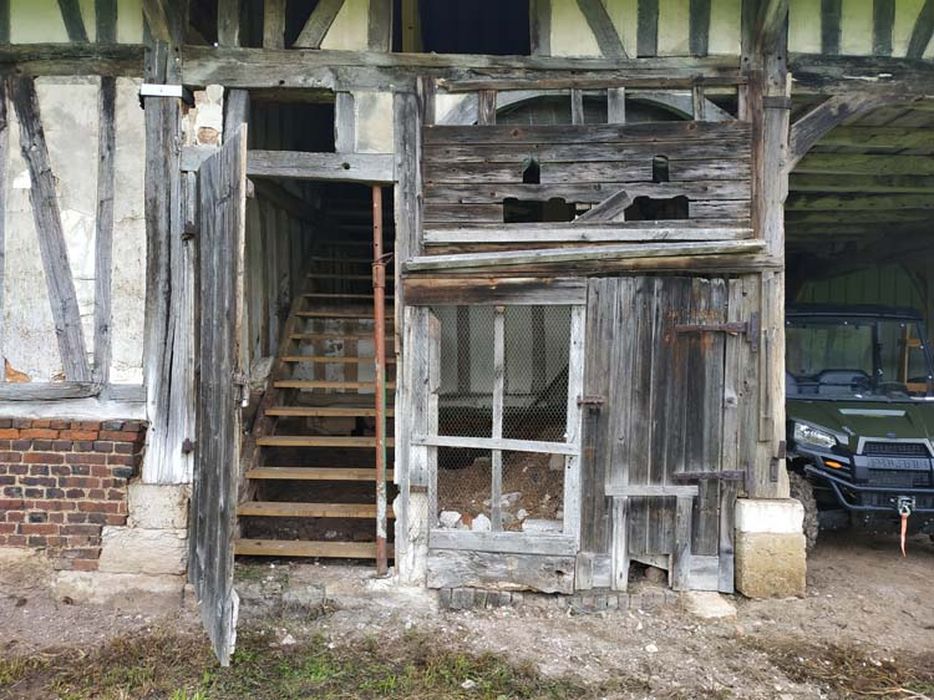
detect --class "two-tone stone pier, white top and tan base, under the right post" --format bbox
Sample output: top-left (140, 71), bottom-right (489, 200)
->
top-left (735, 499), bottom-right (807, 598)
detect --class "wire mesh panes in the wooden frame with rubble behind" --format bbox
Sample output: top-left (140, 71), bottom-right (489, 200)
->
top-left (434, 306), bottom-right (571, 532)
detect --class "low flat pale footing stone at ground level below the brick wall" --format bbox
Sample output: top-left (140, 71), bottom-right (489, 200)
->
top-left (53, 571), bottom-right (185, 604)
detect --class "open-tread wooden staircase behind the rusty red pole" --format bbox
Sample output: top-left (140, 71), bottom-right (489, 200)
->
top-left (234, 253), bottom-right (395, 559)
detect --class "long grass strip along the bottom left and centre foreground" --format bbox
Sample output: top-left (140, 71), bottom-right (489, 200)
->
top-left (0, 629), bottom-right (650, 700)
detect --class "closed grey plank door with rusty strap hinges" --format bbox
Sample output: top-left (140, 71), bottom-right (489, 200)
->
top-left (584, 276), bottom-right (747, 591)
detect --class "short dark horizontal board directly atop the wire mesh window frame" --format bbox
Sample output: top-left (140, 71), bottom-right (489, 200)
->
top-left (403, 275), bottom-right (586, 306)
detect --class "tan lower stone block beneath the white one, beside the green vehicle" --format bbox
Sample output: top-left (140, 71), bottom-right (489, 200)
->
top-left (735, 532), bottom-right (807, 598)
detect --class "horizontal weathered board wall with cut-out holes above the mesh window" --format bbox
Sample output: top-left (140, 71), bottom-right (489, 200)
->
top-left (423, 122), bottom-right (751, 252)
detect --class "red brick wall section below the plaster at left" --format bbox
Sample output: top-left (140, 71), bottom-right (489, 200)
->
top-left (0, 419), bottom-right (146, 571)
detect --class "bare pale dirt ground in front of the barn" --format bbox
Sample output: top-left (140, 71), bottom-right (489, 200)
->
top-left (0, 531), bottom-right (934, 699)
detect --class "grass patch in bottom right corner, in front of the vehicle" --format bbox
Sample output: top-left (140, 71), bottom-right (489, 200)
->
top-left (754, 640), bottom-right (934, 698)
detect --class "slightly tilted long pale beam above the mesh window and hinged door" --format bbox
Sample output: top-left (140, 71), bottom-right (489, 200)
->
top-left (405, 240), bottom-right (764, 272)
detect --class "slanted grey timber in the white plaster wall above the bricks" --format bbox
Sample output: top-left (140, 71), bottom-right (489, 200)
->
top-left (10, 77), bottom-right (91, 382)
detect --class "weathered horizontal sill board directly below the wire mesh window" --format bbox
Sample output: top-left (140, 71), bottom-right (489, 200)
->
top-left (427, 549), bottom-right (574, 594)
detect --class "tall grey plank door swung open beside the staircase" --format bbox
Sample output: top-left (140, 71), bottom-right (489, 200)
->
top-left (188, 126), bottom-right (246, 666)
